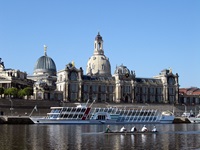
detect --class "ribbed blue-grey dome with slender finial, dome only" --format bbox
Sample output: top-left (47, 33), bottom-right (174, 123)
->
top-left (34, 45), bottom-right (57, 75)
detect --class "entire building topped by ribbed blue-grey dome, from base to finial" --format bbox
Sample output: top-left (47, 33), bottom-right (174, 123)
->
top-left (28, 45), bottom-right (62, 100)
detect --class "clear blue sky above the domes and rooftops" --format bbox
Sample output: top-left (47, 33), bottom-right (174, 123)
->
top-left (0, 0), bottom-right (200, 88)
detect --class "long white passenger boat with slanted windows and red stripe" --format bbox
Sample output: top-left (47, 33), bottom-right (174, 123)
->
top-left (30, 101), bottom-right (174, 124)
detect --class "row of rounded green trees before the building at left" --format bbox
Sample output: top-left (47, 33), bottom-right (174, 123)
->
top-left (0, 87), bottom-right (33, 98)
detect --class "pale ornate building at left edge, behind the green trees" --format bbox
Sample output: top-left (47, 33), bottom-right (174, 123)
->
top-left (0, 58), bottom-right (33, 89)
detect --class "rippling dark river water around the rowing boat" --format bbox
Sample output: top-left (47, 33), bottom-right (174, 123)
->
top-left (0, 124), bottom-right (200, 150)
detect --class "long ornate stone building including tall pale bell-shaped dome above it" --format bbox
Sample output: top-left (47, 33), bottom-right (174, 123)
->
top-left (56, 33), bottom-right (179, 103)
